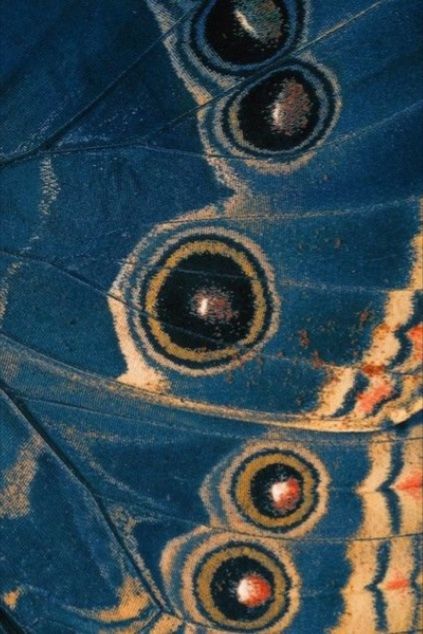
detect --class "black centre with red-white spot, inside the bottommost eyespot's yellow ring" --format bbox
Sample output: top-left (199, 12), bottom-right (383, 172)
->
top-left (210, 556), bottom-right (274, 621)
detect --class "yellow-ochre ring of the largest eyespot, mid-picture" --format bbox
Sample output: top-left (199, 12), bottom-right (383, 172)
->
top-left (145, 240), bottom-right (267, 362)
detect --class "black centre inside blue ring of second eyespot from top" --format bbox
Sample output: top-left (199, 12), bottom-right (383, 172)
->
top-left (238, 70), bottom-right (320, 151)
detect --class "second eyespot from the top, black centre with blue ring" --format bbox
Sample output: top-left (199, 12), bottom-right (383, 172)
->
top-left (221, 63), bottom-right (336, 158)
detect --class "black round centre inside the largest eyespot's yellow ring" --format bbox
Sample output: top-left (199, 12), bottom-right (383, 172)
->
top-left (156, 253), bottom-right (255, 350)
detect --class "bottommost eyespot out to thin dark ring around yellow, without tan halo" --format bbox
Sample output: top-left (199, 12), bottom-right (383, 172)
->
top-left (194, 542), bottom-right (292, 632)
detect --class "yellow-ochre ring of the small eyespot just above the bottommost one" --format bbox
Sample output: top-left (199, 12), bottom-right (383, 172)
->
top-left (234, 451), bottom-right (317, 529)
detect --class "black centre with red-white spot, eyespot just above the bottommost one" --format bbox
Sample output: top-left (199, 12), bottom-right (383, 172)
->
top-left (250, 462), bottom-right (303, 518)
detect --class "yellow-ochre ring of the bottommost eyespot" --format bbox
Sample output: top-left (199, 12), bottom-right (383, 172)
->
top-left (196, 544), bottom-right (287, 631)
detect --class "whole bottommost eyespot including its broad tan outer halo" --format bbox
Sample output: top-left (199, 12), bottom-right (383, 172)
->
top-left (160, 527), bottom-right (301, 634)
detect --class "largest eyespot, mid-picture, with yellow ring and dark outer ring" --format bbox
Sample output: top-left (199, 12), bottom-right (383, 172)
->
top-left (139, 231), bottom-right (274, 374)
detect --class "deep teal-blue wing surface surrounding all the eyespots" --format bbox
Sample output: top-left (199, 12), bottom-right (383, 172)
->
top-left (0, 0), bottom-right (423, 634)
